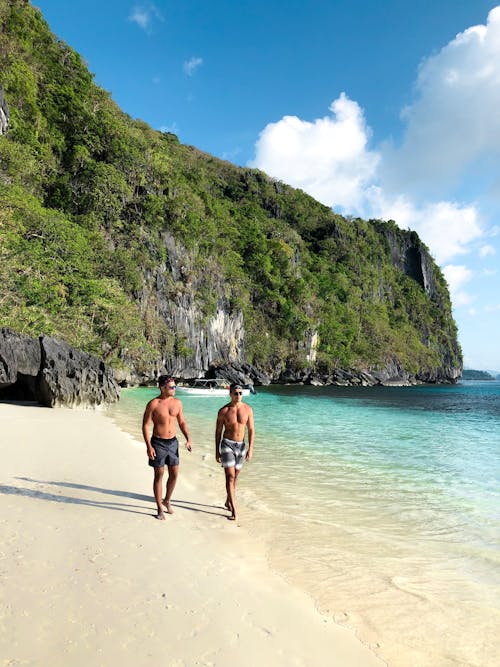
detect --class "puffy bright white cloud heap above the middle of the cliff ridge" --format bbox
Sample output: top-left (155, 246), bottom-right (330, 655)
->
top-left (251, 93), bottom-right (379, 212)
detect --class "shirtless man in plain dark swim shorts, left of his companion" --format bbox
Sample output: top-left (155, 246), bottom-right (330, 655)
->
top-left (142, 375), bottom-right (192, 521)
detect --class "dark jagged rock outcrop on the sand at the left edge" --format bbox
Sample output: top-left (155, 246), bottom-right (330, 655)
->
top-left (0, 329), bottom-right (120, 407)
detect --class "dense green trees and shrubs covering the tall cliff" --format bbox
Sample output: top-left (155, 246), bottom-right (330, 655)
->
top-left (0, 0), bottom-right (461, 373)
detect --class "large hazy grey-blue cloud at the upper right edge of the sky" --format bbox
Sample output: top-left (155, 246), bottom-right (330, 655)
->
top-left (384, 7), bottom-right (500, 192)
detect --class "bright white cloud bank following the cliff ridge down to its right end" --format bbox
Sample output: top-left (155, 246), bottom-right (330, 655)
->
top-left (251, 94), bottom-right (483, 263)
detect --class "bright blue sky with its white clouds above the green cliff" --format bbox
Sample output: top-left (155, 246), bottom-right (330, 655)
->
top-left (33, 0), bottom-right (500, 372)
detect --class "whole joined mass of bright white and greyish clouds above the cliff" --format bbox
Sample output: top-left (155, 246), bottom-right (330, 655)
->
top-left (250, 6), bottom-right (500, 263)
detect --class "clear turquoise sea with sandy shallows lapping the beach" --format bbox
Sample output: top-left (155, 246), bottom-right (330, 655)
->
top-left (108, 382), bottom-right (500, 667)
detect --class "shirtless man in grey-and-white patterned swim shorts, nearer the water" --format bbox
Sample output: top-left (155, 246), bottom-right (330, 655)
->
top-left (215, 384), bottom-right (254, 521)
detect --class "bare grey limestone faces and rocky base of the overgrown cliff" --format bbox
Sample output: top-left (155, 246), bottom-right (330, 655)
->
top-left (128, 228), bottom-right (461, 385)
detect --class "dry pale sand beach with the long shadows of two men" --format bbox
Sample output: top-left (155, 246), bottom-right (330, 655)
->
top-left (0, 404), bottom-right (384, 667)
